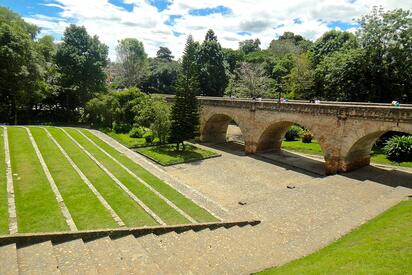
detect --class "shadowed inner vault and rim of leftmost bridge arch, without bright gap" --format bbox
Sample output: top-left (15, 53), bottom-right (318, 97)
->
top-left (200, 113), bottom-right (245, 143)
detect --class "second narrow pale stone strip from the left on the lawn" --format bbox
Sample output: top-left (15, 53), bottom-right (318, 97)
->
top-left (24, 127), bottom-right (77, 231)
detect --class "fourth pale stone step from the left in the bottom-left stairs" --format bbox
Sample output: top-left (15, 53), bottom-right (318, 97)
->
top-left (85, 237), bottom-right (128, 274)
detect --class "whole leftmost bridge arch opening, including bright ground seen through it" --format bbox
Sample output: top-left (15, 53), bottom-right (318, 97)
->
top-left (201, 114), bottom-right (244, 146)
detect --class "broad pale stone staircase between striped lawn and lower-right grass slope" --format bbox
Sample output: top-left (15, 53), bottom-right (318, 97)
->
top-left (0, 178), bottom-right (412, 274)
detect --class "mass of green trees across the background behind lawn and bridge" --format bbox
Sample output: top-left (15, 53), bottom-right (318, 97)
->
top-left (0, 7), bottom-right (412, 128)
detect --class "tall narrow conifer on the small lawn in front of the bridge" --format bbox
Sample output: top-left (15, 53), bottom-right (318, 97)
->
top-left (170, 35), bottom-right (200, 150)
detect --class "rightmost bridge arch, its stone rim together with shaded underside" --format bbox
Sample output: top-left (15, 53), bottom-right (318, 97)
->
top-left (340, 123), bottom-right (412, 172)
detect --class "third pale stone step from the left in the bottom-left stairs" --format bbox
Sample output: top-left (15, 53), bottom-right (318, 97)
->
top-left (53, 239), bottom-right (98, 275)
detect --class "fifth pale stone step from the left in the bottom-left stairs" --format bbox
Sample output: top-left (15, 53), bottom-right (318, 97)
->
top-left (112, 235), bottom-right (162, 274)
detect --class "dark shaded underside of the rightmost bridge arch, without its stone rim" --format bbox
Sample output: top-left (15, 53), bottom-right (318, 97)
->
top-left (342, 130), bottom-right (412, 171)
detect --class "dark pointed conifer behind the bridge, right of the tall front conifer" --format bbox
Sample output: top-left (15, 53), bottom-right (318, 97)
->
top-left (197, 30), bottom-right (228, 96)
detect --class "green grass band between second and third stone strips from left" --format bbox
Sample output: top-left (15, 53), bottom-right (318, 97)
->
top-left (30, 127), bottom-right (117, 230)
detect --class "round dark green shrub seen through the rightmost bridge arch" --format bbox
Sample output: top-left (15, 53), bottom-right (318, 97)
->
top-left (383, 136), bottom-right (412, 162)
